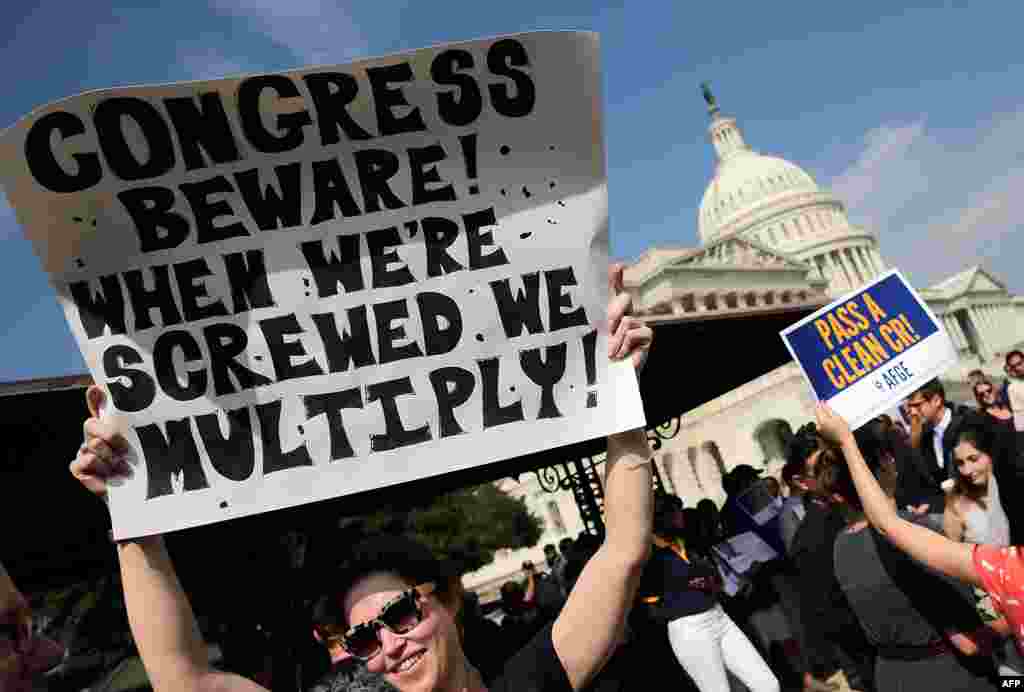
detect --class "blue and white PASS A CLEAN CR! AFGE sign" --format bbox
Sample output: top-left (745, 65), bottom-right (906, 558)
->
top-left (781, 270), bottom-right (956, 428)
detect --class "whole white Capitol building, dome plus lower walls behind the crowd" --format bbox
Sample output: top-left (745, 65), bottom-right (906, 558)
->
top-left (465, 89), bottom-right (1024, 591)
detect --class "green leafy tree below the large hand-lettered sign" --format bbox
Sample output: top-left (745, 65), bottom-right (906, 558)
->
top-left (366, 483), bottom-right (544, 572)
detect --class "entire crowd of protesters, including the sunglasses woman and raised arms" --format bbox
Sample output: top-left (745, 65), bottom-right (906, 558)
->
top-left (0, 284), bottom-right (1024, 692)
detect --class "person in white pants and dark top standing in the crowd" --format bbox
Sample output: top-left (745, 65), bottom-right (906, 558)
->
top-left (639, 495), bottom-right (779, 692)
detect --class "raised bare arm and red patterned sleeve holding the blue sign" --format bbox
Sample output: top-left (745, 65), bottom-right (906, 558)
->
top-left (817, 403), bottom-right (1024, 679)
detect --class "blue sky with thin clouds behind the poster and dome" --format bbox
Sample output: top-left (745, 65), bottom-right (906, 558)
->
top-left (0, 0), bottom-right (1024, 381)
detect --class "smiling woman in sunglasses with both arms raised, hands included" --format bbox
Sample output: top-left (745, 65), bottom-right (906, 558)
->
top-left (71, 265), bottom-right (653, 692)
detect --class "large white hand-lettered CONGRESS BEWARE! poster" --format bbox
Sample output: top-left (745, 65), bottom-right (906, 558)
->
top-left (0, 33), bottom-right (644, 537)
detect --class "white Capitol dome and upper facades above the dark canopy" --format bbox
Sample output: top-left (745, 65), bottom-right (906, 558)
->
top-left (625, 84), bottom-right (1024, 379)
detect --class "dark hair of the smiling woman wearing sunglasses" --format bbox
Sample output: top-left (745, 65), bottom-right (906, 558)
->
top-left (313, 535), bottom-right (462, 628)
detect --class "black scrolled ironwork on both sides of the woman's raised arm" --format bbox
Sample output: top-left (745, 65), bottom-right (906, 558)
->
top-left (534, 416), bottom-right (682, 536)
